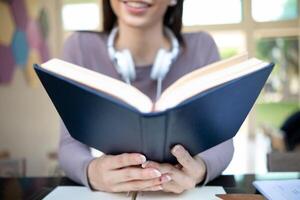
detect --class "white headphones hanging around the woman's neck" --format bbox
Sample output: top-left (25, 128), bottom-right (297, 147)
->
top-left (107, 27), bottom-right (179, 99)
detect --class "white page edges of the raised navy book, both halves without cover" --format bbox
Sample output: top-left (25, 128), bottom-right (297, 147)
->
top-left (37, 53), bottom-right (267, 113)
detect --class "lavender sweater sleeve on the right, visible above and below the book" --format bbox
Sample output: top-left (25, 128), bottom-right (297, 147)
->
top-left (193, 32), bottom-right (234, 185)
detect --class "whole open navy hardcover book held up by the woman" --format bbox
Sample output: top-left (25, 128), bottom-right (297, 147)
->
top-left (34, 54), bottom-right (273, 162)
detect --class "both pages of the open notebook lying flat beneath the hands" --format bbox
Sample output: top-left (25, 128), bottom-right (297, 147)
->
top-left (44, 186), bottom-right (225, 200)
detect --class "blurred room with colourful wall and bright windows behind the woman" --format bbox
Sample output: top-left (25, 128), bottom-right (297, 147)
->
top-left (0, 0), bottom-right (300, 176)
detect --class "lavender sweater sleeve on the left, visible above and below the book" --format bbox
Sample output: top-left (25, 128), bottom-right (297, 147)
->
top-left (58, 33), bottom-right (94, 186)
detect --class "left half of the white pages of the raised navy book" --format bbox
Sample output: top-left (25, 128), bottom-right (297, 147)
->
top-left (41, 59), bottom-right (153, 113)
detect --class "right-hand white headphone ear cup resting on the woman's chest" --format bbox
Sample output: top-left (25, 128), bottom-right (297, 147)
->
top-left (150, 49), bottom-right (172, 80)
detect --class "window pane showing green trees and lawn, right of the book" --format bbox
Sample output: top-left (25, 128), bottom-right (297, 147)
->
top-left (256, 36), bottom-right (300, 128)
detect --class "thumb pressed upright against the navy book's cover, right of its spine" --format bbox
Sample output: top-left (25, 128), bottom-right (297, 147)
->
top-left (171, 145), bottom-right (197, 173)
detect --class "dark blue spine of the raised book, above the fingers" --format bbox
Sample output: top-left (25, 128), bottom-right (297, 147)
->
top-left (140, 115), bottom-right (166, 162)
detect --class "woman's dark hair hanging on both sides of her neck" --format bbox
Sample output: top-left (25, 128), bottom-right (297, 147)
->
top-left (103, 0), bottom-right (184, 45)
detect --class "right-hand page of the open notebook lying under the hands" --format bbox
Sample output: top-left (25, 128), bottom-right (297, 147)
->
top-left (136, 186), bottom-right (226, 200)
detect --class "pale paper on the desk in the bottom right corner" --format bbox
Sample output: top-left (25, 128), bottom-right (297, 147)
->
top-left (253, 179), bottom-right (300, 200)
